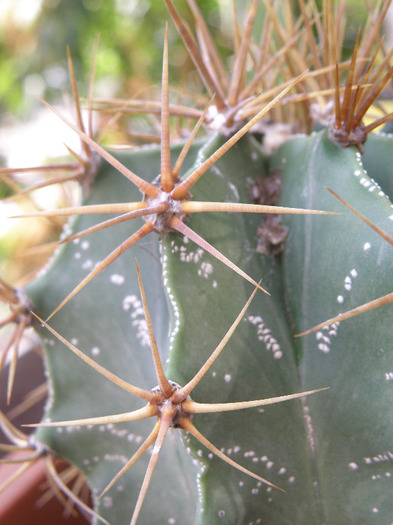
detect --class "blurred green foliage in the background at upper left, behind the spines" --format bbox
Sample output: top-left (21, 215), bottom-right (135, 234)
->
top-left (0, 0), bottom-right (219, 117)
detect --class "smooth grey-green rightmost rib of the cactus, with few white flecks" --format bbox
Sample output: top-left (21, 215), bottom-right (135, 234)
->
top-left (272, 128), bottom-right (393, 524)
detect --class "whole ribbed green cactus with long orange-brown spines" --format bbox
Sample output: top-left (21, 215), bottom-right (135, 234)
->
top-left (0, 0), bottom-right (393, 525)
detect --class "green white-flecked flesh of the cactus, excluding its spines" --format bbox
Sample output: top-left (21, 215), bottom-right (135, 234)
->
top-left (20, 123), bottom-right (393, 525)
